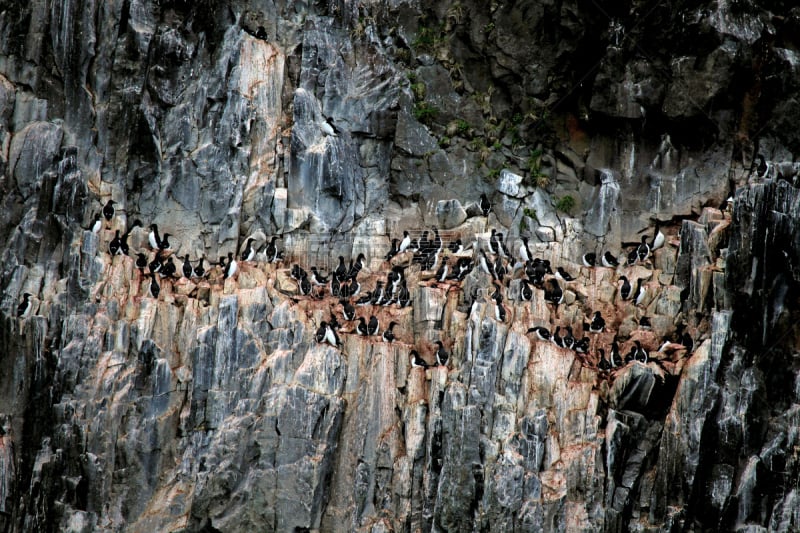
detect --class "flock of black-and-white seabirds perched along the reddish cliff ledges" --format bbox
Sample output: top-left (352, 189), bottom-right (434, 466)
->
top-left (17, 194), bottom-right (693, 373)
